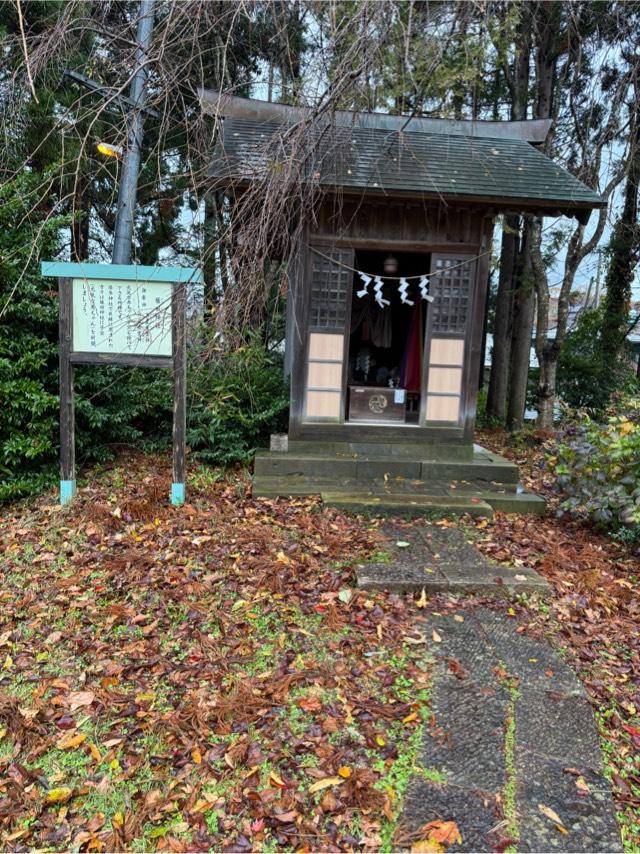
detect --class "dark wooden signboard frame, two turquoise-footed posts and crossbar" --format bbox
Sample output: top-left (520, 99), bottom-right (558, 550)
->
top-left (58, 277), bottom-right (187, 504)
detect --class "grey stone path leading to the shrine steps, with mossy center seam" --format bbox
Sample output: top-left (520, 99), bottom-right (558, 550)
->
top-left (358, 525), bottom-right (622, 852)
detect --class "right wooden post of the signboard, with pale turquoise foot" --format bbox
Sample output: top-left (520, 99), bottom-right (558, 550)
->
top-left (171, 282), bottom-right (187, 504)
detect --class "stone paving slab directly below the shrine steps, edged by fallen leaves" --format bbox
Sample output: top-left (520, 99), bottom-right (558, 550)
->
top-left (356, 524), bottom-right (549, 598)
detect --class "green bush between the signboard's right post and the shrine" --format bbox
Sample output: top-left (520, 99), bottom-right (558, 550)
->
top-left (187, 336), bottom-right (289, 465)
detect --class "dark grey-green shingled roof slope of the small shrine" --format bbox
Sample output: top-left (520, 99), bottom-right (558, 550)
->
top-left (205, 93), bottom-right (606, 219)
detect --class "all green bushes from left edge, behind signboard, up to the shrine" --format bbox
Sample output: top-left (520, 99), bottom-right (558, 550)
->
top-left (0, 175), bottom-right (289, 501)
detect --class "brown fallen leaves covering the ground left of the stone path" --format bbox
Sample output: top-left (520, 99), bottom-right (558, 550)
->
top-left (0, 456), bottom-right (429, 851)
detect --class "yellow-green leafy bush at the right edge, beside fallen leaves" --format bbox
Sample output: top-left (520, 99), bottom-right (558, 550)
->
top-left (549, 396), bottom-right (640, 540)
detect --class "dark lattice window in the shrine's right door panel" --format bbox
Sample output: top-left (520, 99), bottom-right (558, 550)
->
top-left (430, 258), bottom-right (473, 335)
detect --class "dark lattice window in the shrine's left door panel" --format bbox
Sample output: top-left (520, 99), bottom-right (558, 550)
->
top-left (309, 248), bottom-right (353, 329)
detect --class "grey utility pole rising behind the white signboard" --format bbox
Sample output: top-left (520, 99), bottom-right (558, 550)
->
top-left (111, 0), bottom-right (155, 264)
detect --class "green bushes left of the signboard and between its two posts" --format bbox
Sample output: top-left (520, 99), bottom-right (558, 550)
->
top-left (0, 175), bottom-right (178, 501)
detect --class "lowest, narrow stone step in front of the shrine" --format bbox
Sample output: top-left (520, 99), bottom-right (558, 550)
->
top-left (321, 492), bottom-right (493, 519)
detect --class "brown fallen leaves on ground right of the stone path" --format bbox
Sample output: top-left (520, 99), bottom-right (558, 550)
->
top-left (470, 432), bottom-right (640, 850)
